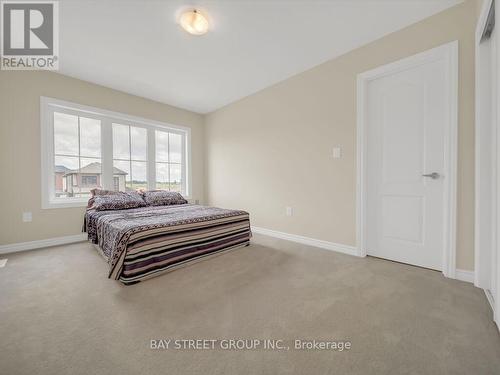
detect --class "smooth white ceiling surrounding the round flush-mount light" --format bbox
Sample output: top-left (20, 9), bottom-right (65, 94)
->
top-left (60, 0), bottom-right (461, 113)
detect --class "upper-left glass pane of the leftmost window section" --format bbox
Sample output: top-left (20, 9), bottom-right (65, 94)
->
top-left (54, 112), bottom-right (78, 156)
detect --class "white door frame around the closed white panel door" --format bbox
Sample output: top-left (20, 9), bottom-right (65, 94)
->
top-left (356, 41), bottom-right (458, 278)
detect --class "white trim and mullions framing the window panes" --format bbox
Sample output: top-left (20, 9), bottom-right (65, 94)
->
top-left (40, 96), bottom-right (192, 209)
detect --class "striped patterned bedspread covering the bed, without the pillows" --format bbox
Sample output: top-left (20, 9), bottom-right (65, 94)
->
top-left (85, 204), bottom-right (252, 284)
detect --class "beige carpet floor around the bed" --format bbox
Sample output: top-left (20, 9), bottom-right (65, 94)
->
top-left (0, 235), bottom-right (500, 375)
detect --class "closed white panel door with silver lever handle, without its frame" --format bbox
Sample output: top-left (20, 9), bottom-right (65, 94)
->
top-left (365, 53), bottom-right (451, 270)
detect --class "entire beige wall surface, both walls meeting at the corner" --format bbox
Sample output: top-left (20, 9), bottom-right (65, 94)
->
top-left (0, 0), bottom-right (481, 270)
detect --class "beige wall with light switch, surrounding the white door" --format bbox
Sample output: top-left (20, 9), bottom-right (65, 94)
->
top-left (205, 1), bottom-right (478, 270)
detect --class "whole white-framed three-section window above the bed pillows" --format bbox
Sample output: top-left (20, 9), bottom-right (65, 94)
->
top-left (41, 98), bottom-right (190, 208)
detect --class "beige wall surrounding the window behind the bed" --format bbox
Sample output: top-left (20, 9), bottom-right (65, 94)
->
top-left (0, 71), bottom-right (204, 245)
